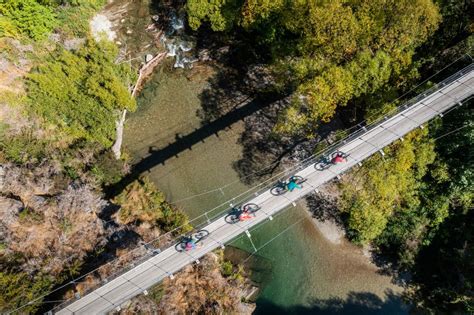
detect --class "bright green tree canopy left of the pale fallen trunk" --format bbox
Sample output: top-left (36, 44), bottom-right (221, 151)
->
top-left (27, 40), bottom-right (136, 147)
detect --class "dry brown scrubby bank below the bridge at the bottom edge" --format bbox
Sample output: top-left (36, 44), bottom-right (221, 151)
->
top-left (114, 253), bottom-right (255, 315)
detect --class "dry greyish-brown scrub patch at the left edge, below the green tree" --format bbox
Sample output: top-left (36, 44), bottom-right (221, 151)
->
top-left (0, 163), bottom-right (109, 276)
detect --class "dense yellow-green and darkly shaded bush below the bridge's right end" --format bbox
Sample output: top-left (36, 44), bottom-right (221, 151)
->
top-left (341, 101), bottom-right (474, 313)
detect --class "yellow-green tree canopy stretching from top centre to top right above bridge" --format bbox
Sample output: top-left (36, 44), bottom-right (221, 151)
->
top-left (187, 0), bottom-right (441, 134)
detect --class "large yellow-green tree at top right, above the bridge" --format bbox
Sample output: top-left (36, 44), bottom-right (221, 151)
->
top-left (276, 0), bottom-right (440, 133)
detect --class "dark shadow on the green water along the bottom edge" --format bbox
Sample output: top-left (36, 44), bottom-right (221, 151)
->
top-left (253, 290), bottom-right (409, 315)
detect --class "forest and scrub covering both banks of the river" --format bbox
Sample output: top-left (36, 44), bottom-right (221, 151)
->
top-left (0, 0), bottom-right (474, 314)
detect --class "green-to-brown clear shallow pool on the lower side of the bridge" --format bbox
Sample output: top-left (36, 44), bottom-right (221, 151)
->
top-left (231, 206), bottom-right (407, 314)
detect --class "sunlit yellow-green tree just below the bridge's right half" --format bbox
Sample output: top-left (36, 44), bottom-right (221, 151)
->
top-left (340, 128), bottom-right (435, 244)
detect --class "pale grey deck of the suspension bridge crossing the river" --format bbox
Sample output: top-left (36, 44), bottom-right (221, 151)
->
top-left (40, 64), bottom-right (474, 314)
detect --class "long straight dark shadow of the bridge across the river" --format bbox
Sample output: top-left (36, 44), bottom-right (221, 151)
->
top-left (105, 95), bottom-right (282, 196)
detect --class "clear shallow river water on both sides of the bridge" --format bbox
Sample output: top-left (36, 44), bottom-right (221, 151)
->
top-left (125, 62), bottom-right (407, 314)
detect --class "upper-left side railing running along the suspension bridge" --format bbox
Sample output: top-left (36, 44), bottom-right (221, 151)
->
top-left (49, 63), bottom-right (474, 311)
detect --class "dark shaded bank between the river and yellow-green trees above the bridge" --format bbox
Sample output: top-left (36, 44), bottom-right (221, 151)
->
top-left (194, 66), bottom-right (341, 185)
